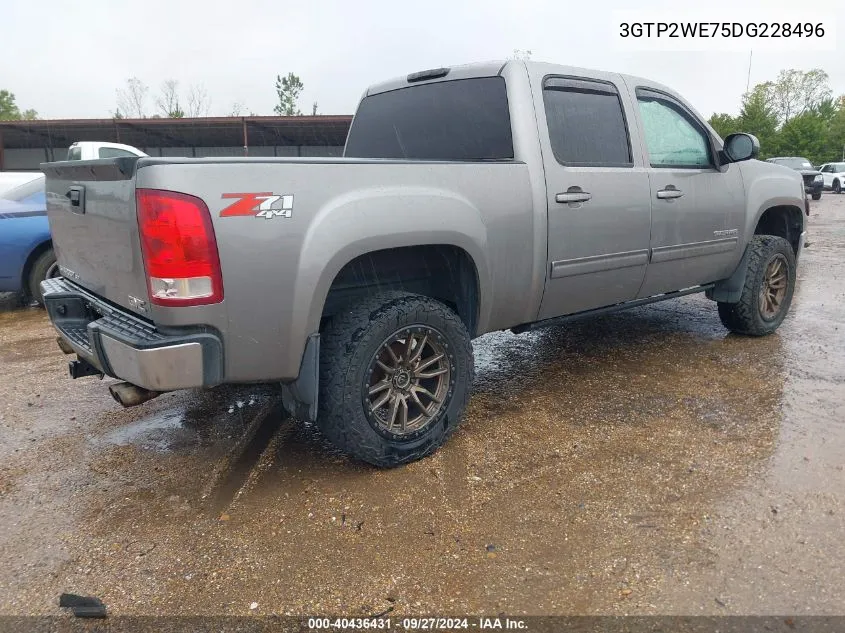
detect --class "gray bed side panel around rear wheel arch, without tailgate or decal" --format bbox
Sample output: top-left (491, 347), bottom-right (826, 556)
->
top-left (137, 159), bottom-right (537, 382)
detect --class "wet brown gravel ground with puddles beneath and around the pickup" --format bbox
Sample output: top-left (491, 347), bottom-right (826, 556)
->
top-left (0, 195), bottom-right (845, 617)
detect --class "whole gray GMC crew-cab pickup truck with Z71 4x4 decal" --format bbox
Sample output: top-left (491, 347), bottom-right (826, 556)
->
top-left (43, 61), bottom-right (808, 466)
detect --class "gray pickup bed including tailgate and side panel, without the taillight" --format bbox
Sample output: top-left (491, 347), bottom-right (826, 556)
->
top-left (43, 158), bottom-right (545, 382)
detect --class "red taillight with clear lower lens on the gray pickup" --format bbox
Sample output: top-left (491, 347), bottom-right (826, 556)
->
top-left (135, 189), bottom-right (223, 306)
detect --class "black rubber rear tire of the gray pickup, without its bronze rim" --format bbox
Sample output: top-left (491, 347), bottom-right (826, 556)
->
top-left (317, 292), bottom-right (474, 467)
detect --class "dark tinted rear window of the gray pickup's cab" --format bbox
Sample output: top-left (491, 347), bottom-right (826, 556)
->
top-left (344, 77), bottom-right (513, 160)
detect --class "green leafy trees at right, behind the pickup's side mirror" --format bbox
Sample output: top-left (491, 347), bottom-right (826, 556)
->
top-left (710, 68), bottom-right (845, 165)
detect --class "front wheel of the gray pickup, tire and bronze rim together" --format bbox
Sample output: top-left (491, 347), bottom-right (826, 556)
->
top-left (719, 235), bottom-right (795, 336)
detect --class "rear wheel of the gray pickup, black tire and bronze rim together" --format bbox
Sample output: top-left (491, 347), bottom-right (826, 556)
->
top-left (317, 292), bottom-right (474, 467)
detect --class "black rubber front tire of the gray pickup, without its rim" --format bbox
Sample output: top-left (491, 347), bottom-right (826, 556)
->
top-left (718, 235), bottom-right (795, 336)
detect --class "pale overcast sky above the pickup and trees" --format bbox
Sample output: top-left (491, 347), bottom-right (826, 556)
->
top-left (0, 0), bottom-right (845, 118)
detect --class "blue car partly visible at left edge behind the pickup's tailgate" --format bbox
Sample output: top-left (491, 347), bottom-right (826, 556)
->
top-left (0, 174), bottom-right (59, 303)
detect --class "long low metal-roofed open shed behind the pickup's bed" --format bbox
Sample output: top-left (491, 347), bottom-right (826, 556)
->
top-left (0, 115), bottom-right (352, 171)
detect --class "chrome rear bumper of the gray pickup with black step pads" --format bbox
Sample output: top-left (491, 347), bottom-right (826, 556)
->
top-left (41, 277), bottom-right (223, 391)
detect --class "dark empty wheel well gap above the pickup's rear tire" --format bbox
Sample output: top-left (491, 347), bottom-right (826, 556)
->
top-left (320, 245), bottom-right (479, 336)
